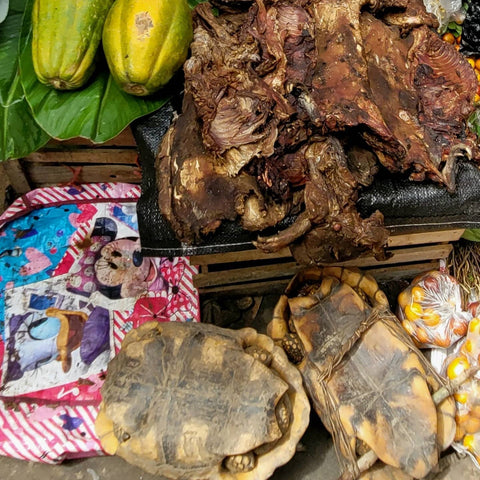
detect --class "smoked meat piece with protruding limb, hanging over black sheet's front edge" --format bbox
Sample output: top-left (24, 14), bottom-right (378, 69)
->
top-left (254, 136), bottom-right (388, 263)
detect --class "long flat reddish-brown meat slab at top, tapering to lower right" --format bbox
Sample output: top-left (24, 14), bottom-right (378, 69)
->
top-left (301, 0), bottom-right (404, 161)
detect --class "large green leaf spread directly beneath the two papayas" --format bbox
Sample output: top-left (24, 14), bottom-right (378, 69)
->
top-left (20, 2), bottom-right (168, 143)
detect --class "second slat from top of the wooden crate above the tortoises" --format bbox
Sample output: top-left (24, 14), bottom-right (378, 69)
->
top-left (192, 244), bottom-right (453, 288)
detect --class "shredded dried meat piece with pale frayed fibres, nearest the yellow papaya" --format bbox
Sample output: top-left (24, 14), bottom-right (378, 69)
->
top-left (184, 4), bottom-right (290, 176)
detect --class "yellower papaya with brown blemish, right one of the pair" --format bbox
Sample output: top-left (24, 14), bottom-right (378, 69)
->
top-left (102, 0), bottom-right (193, 96)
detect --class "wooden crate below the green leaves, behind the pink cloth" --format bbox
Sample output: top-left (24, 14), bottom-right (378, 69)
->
top-left (1, 127), bottom-right (141, 195)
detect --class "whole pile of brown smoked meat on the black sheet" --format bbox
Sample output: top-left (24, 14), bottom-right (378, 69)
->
top-left (156, 0), bottom-right (480, 263)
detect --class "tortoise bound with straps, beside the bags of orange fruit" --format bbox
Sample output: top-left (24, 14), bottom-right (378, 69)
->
top-left (268, 267), bottom-right (455, 478)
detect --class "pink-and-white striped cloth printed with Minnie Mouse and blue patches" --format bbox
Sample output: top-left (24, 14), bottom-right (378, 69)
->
top-left (0, 183), bottom-right (199, 463)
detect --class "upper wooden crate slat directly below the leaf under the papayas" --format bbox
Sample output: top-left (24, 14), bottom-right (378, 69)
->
top-left (23, 148), bottom-right (138, 165)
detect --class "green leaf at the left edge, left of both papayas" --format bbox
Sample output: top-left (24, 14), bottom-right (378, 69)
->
top-left (0, 0), bottom-right (49, 161)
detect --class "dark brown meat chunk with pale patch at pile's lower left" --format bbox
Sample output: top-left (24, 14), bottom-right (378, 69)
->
top-left (156, 94), bottom-right (291, 243)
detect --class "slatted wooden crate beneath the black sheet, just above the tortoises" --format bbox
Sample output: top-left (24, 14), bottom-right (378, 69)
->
top-left (190, 229), bottom-right (464, 295)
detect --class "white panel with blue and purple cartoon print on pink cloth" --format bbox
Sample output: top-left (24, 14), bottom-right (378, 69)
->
top-left (3, 284), bottom-right (110, 393)
